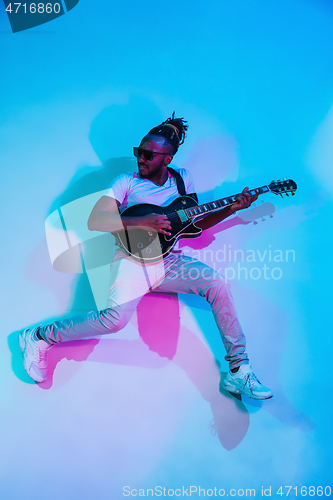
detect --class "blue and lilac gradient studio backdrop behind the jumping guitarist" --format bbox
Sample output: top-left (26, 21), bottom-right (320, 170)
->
top-left (0, 0), bottom-right (333, 500)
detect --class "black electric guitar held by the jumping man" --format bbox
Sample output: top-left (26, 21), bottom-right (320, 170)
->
top-left (116, 179), bottom-right (297, 262)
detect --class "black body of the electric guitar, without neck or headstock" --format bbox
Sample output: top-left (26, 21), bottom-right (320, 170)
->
top-left (117, 196), bottom-right (202, 262)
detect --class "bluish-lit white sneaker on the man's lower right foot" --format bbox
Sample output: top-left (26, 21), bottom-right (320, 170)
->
top-left (223, 365), bottom-right (273, 399)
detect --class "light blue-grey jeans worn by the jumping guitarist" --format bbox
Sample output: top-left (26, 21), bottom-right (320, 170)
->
top-left (39, 250), bottom-right (248, 368)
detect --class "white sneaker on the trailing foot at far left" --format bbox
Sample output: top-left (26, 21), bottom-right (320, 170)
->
top-left (19, 326), bottom-right (53, 382)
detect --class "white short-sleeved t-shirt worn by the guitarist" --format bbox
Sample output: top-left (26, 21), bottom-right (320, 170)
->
top-left (105, 167), bottom-right (195, 212)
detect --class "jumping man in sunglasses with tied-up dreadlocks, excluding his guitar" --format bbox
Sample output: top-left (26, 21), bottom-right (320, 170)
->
top-left (19, 113), bottom-right (273, 399)
